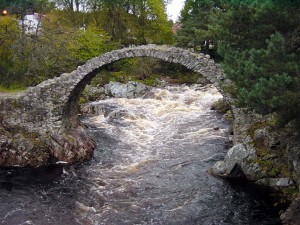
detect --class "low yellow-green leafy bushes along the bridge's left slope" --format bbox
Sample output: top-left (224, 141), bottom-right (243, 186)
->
top-left (0, 7), bottom-right (115, 87)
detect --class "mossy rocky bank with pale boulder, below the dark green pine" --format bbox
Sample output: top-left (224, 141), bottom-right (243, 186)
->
top-left (210, 99), bottom-right (300, 225)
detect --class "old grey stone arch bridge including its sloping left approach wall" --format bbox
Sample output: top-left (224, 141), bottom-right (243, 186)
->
top-left (0, 45), bottom-right (228, 165)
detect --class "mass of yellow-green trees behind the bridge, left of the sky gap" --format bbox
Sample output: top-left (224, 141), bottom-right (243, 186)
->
top-left (0, 0), bottom-right (173, 87)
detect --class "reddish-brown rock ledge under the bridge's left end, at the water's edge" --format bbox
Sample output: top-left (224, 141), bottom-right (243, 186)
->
top-left (0, 121), bottom-right (95, 167)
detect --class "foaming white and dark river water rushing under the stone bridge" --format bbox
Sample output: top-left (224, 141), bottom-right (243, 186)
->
top-left (0, 86), bottom-right (280, 225)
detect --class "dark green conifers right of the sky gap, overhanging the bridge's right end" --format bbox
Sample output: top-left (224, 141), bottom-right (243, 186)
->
top-left (175, 0), bottom-right (300, 123)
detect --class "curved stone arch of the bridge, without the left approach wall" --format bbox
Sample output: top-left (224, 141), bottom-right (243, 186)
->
top-left (63, 45), bottom-right (225, 131)
